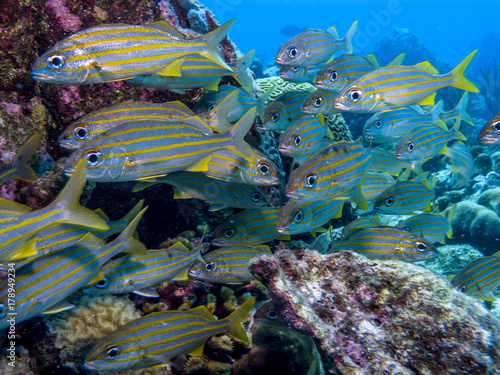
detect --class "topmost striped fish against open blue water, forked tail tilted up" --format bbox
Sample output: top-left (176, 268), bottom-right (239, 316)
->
top-left (276, 21), bottom-right (358, 67)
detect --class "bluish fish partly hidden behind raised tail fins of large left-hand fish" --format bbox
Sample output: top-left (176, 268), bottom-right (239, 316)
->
top-left (193, 85), bottom-right (274, 123)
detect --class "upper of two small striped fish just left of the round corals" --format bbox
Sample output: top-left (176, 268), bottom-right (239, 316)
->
top-left (373, 173), bottom-right (435, 215)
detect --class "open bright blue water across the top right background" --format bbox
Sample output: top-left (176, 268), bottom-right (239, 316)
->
top-left (203, 0), bottom-right (500, 67)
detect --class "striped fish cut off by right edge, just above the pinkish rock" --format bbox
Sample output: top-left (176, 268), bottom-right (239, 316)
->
top-left (451, 252), bottom-right (500, 301)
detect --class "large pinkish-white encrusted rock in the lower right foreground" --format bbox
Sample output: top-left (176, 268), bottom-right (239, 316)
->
top-left (250, 250), bottom-right (500, 375)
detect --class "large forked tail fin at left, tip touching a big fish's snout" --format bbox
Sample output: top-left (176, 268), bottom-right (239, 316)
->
top-left (51, 159), bottom-right (109, 230)
